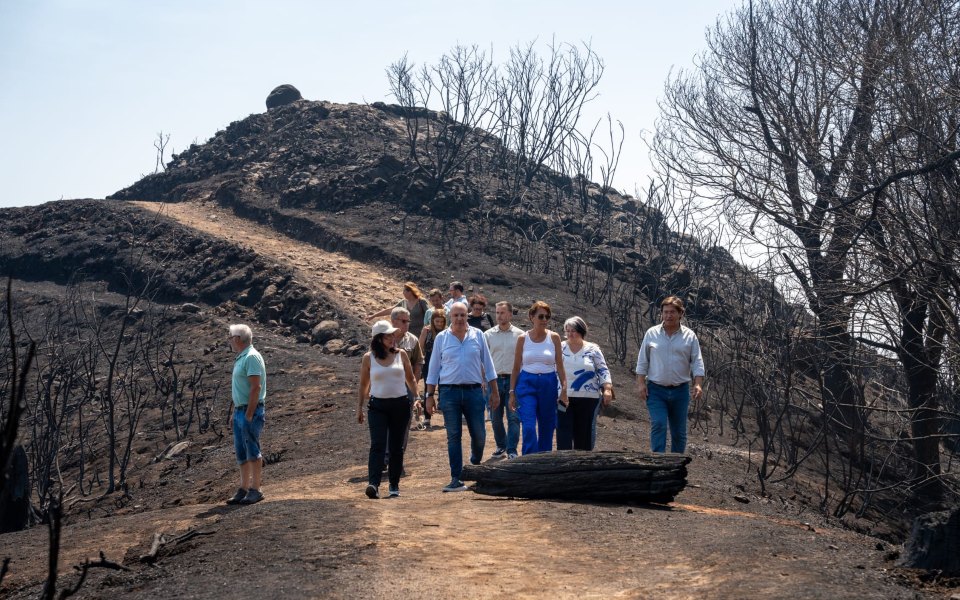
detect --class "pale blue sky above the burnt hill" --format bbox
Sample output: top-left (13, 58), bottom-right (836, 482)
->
top-left (0, 0), bottom-right (741, 206)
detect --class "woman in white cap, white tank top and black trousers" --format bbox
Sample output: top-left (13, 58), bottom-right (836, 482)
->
top-left (357, 321), bottom-right (423, 499)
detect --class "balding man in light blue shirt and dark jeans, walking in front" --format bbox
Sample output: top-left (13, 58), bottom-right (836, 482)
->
top-left (427, 302), bottom-right (500, 492)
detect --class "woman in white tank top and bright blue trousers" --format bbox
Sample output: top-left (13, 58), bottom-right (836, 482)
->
top-left (510, 300), bottom-right (567, 454)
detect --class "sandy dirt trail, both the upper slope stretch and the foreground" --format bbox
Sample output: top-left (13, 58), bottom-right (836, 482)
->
top-left (0, 203), bottom-right (928, 599)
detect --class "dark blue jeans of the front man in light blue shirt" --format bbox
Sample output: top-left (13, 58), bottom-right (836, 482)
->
top-left (440, 384), bottom-right (487, 479)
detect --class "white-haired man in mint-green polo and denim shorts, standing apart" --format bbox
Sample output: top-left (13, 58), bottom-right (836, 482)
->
top-left (227, 325), bottom-right (267, 504)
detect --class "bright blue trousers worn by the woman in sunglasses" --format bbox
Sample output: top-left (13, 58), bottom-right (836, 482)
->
top-left (515, 371), bottom-right (560, 454)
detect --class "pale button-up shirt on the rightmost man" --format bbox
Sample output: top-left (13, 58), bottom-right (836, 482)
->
top-left (636, 323), bottom-right (706, 385)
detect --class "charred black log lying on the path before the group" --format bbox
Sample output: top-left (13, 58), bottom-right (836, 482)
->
top-left (460, 450), bottom-right (690, 503)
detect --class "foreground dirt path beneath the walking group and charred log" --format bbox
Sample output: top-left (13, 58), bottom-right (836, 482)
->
top-left (0, 408), bottom-right (914, 598)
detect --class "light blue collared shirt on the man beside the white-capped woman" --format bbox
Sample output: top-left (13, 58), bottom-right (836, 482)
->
top-left (427, 326), bottom-right (497, 385)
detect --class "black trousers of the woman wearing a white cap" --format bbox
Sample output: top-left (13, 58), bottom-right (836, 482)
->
top-left (367, 396), bottom-right (410, 487)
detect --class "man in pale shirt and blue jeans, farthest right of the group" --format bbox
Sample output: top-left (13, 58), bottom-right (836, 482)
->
top-left (636, 296), bottom-right (706, 453)
